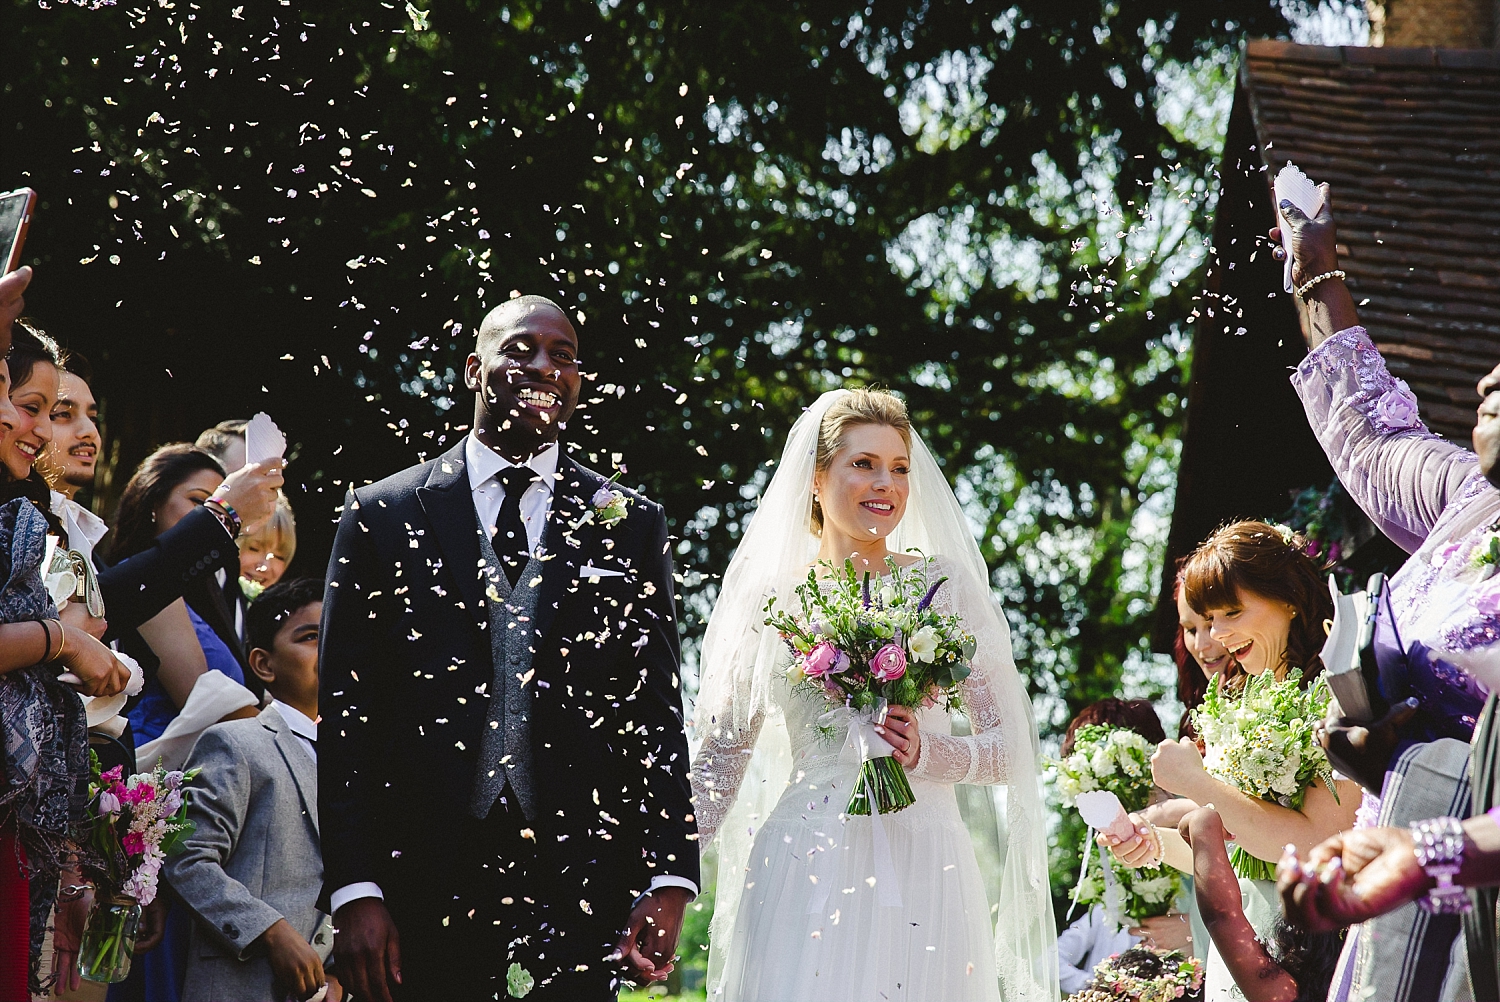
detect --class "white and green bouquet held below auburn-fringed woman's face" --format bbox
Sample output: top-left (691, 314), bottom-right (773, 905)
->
top-left (1193, 668), bottom-right (1338, 881)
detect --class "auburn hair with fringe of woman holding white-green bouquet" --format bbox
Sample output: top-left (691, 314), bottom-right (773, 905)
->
top-left (1182, 522), bottom-right (1334, 681)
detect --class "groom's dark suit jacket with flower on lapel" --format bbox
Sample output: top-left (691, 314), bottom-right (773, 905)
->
top-left (318, 443), bottom-right (699, 902)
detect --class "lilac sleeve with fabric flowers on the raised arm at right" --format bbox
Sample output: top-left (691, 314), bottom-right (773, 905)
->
top-left (1292, 327), bottom-right (1478, 554)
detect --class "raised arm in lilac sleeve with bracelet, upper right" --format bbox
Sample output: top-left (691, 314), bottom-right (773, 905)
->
top-left (1271, 185), bottom-right (1478, 552)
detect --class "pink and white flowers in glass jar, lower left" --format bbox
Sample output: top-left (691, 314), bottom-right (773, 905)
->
top-left (78, 753), bottom-right (198, 983)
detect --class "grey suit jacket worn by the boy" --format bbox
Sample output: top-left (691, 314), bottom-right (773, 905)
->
top-left (162, 707), bottom-right (333, 1002)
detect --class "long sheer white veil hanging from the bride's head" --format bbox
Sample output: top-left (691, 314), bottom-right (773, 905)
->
top-left (695, 390), bottom-right (1059, 1002)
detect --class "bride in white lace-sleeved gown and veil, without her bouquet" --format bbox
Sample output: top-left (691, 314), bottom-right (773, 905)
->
top-left (693, 390), bottom-right (1059, 1002)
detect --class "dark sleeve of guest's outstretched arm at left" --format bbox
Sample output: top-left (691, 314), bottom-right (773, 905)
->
top-left (99, 509), bottom-right (239, 641)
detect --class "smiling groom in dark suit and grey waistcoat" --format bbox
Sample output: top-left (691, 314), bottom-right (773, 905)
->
top-left (318, 296), bottom-right (699, 1002)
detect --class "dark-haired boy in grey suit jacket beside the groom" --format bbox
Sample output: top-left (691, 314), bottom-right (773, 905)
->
top-left (162, 581), bottom-right (339, 1002)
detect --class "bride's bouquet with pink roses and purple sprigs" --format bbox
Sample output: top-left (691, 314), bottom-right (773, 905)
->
top-left (765, 557), bottom-right (975, 815)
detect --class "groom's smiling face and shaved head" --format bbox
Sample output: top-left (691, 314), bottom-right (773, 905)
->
top-left (464, 296), bottom-right (582, 461)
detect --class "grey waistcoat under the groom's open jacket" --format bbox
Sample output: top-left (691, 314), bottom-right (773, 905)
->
top-left (470, 534), bottom-right (545, 821)
